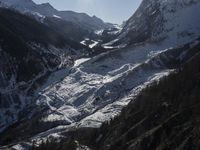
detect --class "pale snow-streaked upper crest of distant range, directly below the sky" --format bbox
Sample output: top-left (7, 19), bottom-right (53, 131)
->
top-left (1, 0), bottom-right (110, 31)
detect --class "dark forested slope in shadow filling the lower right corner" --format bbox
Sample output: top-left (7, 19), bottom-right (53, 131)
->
top-left (94, 42), bottom-right (200, 150)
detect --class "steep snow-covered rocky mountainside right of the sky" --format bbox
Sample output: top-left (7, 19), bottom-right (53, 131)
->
top-left (114, 0), bottom-right (200, 45)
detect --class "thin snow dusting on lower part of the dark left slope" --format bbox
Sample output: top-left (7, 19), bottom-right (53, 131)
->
top-left (0, 43), bottom-right (82, 132)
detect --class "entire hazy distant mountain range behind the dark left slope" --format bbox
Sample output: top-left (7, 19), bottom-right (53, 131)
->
top-left (0, 0), bottom-right (114, 42)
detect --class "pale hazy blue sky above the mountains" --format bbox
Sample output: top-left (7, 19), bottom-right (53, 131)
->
top-left (33, 0), bottom-right (142, 24)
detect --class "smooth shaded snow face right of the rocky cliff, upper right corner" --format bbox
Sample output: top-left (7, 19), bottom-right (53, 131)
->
top-left (160, 0), bottom-right (200, 45)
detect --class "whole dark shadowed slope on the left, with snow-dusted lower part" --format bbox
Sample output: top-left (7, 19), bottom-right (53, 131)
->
top-left (0, 8), bottom-right (88, 131)
